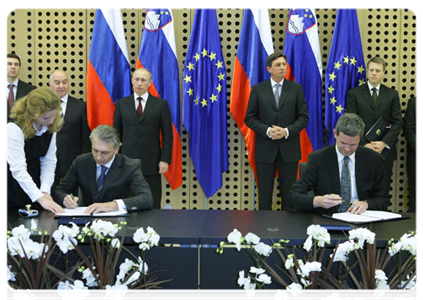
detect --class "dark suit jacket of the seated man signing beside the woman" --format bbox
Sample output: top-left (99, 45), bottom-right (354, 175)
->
top-left (54, 153), bottom-right (153, 211)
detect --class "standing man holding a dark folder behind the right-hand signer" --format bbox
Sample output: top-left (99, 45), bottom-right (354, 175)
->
top-left (346, 57), bottom-right (402, 198)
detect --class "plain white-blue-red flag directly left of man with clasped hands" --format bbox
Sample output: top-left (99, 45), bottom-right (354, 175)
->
top-left (230, 8), bottom-right (273, 178)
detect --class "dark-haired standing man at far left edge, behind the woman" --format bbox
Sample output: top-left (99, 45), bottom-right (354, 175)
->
top-left (5, 54), bottom-right (36, 124)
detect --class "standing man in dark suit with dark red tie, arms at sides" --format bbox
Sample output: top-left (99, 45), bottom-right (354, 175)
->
top-left (113, 68), bottom-right (173, 208)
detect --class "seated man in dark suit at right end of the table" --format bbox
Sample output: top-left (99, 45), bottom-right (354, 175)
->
top-left (288, 113), bottom-right (389, 214)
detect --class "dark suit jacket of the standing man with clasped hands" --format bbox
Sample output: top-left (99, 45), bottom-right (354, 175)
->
top-left (245, 79), bottom-right (309, 163)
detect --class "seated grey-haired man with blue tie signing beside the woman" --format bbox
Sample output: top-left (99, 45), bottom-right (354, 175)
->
top-left (54, 125), bottom-right (153, 214)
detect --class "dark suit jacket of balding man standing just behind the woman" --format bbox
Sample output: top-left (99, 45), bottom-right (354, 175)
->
top-left (56, 96), bottom-right (91, 178)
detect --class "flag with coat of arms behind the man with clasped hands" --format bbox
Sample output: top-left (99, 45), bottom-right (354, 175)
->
top-left (284, 8), bottom-right (323, 162)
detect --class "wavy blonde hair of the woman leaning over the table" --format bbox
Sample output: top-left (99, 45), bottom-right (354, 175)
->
top-left (10, 88), bottom-right (63, 140)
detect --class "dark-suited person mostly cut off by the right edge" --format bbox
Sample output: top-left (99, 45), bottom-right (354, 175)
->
top-left (403, 96), bottom-right (420, 212)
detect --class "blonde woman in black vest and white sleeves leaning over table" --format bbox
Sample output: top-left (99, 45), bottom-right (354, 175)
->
top-left (5, 88), bottom-right (63, 213)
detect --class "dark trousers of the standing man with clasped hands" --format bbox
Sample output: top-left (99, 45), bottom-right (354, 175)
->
top-left (256, 152), bottom-right (298, 210)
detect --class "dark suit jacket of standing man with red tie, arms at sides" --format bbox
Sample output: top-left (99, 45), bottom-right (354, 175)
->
top-left (113, 94), bottom-right (173, 175)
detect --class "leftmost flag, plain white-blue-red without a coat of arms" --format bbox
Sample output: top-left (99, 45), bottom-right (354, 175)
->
top-left (87, 8), bottom-right (131, 130)
